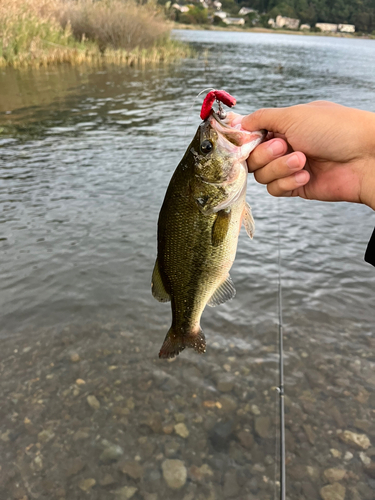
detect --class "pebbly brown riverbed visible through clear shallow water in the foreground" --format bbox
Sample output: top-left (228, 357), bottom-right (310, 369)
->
top-left (0, 322), bottom-right (375, 500)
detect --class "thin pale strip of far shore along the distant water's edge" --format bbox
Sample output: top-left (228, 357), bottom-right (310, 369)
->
top-left (172, 22), bottom-right (375, 40)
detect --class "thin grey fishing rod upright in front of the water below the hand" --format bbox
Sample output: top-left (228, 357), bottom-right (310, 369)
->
top-left (277, 198), bottom-right (286, 500)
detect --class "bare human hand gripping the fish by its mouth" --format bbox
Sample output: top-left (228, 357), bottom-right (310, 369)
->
top-left (242, 101), bottom-right (375, 210)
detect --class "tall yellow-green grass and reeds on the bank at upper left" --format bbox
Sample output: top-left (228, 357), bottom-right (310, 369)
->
top-left (0, 0), bottom-right (190, 67)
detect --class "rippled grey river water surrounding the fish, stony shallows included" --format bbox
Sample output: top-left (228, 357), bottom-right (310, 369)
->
top-left (0, 31), bottom-right (375, 500)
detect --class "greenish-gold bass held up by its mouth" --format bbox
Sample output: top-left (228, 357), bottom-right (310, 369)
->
top-left (151, 110), bottom-right (266, 358)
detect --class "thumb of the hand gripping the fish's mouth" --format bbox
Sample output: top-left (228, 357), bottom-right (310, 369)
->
top-left (241, 108), bottom-right (290, 134)
